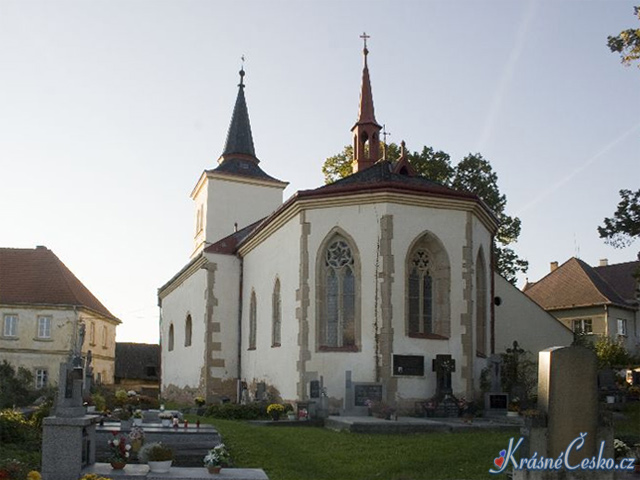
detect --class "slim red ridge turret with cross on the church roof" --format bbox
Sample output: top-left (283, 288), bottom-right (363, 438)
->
top-left (351, 33), bottom-right (382, 173)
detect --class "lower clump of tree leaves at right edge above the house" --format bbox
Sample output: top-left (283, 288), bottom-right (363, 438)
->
top-left (598, 189), bottom-right (640, 248)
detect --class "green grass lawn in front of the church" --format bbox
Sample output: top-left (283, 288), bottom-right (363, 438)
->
top-left (190, 417), bottom-right (519, 480)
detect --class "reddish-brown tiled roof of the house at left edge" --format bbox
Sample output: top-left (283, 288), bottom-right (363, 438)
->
top-left (0, 247), bottom-right (118, 320)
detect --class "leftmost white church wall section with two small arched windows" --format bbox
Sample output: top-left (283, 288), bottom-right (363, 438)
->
top-left (160, 270), bottom-right (206, 394)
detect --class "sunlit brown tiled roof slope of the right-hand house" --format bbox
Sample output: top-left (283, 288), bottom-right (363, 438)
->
top-left (524, 258), bottom-right (632, 310)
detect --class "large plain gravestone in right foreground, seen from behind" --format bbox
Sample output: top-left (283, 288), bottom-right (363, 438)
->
top-left (513, 346), bottom-right (614, 480)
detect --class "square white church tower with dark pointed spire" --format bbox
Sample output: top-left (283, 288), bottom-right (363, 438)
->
top-left (191, 68), bottom-right (288, 258)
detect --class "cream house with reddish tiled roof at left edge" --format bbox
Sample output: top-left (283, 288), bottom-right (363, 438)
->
top-left (0, 246), bottom-right (121, 388)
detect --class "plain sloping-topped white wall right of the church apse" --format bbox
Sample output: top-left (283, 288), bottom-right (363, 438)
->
top-left (494, 273), bottom-right (573, 359)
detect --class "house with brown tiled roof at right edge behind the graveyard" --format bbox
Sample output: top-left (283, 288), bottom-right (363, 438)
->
top-left (524, 257), bottom-right (640, 354)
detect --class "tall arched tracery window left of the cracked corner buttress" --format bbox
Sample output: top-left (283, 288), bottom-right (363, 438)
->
top-left (318, 235), bottom-right (359, 350)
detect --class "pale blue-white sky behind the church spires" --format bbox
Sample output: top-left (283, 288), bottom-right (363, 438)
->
top-left (0, 0), bottom-right (640, 343)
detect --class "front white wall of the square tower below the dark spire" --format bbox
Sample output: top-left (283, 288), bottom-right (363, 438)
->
top-left (204, 178), bottom-right (284, 249)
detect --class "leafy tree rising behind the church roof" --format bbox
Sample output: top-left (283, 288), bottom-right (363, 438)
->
top-left (322, 143), bottom-right (529, 284)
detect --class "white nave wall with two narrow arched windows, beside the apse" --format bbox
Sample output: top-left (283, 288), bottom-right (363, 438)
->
top-left (241, 216), bottom-right (301, 400)
